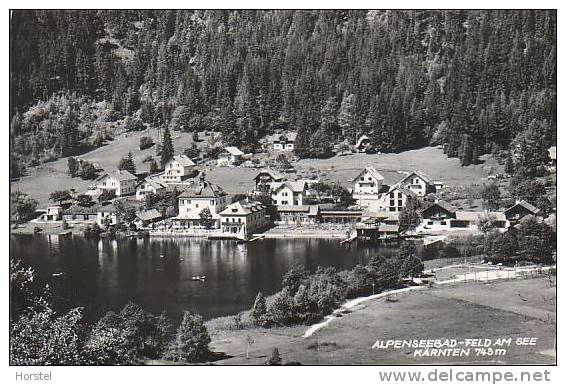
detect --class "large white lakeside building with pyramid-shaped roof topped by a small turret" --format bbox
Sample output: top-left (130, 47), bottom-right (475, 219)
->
top-left (172, 174), bottom-right (227, 228)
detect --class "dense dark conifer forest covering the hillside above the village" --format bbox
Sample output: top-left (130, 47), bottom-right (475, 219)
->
top-left (10, 10), bottom-right (556, 171)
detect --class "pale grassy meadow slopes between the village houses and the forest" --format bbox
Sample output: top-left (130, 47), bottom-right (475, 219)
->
top-left (11, 129), bottom-right (499, 207)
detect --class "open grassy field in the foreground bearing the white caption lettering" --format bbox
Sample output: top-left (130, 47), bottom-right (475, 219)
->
top-left (211, 278), bottom-right (556, 365)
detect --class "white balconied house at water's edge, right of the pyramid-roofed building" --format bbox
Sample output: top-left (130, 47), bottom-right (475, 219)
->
top-left (220, 200), bottom-right (270, 239)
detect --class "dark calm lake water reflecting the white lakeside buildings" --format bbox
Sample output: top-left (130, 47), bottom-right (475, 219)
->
top-left (10, 235), bottom-right (404, 320)
